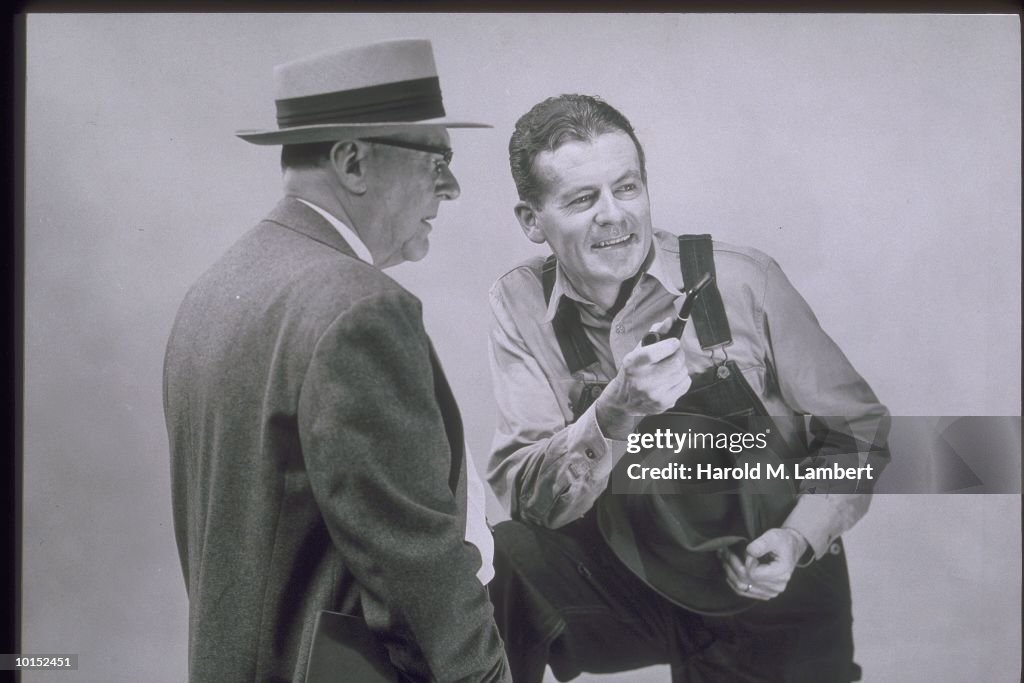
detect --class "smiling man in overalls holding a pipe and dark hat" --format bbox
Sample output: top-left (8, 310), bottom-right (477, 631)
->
top-left (488, 95), bottom-right (888, 683)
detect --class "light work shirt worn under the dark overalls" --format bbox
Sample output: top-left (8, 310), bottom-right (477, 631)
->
top-left (487, 231), bottom-right (889, 558)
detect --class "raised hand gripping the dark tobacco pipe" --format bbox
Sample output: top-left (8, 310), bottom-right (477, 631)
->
top-left (595, 317), bottom-right (690, 439)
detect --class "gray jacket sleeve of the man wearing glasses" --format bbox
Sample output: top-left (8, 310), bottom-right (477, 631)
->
top-left (299, 291), bottom-right (511, 681)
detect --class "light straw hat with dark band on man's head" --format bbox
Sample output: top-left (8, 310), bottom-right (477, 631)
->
top-left (236, 39), bottom-right (490, 144)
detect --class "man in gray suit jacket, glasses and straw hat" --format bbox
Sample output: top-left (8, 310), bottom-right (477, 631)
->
top-left (164, 40), bottom-right (511, 681)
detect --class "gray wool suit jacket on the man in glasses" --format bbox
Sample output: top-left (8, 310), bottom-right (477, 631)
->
top-left (164, 198), bottom-right (508, 682)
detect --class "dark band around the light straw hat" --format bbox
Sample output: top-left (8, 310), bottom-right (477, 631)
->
top-left (276, 76), bottom-right (444, 128)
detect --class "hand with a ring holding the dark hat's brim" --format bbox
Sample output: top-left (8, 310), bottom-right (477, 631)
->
top-left (720, 528), bottom-right (807, 600)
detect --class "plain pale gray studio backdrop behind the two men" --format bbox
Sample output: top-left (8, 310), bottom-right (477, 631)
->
top-left (23, 14), bottom-right (1021, 681)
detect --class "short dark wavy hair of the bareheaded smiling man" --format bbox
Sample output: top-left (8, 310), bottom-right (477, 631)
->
top-left (509, 94), bottom-right (647, 204)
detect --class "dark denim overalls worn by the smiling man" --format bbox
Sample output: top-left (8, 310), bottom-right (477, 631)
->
top-left (490, 236), bottom-right (859, 683)
